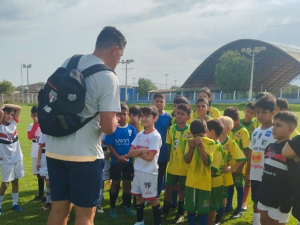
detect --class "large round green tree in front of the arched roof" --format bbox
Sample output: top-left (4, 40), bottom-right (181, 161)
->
top-left (214, 51), bottom-right (251, 97)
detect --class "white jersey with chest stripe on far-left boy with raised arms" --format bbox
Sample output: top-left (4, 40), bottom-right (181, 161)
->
top-left (0, 120), bottom-right (23, 165)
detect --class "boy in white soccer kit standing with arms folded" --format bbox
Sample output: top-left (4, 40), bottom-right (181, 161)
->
top-left (126, 106), bottom-right (162, 225)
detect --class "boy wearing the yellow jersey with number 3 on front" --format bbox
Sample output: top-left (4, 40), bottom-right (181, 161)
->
top-left (163, 104), bottom-right (192, 224)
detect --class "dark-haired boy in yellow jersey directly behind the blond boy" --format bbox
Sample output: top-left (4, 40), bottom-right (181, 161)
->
top-left (224, 107), bottom-right (250, 219)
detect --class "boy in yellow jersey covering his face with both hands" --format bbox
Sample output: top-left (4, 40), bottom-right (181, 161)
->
top-left (184, 119), bottom-right (215, 225)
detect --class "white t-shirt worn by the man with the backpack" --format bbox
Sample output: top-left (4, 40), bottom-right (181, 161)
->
top-left (46, 55), bottom-right (121, 162)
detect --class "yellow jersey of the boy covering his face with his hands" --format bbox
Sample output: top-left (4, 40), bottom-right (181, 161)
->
top-left (185, 137), bottom-right (216, 191)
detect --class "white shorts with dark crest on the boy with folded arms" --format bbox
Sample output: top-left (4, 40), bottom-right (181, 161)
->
top-left (131, 170), bottom-right (158, 200)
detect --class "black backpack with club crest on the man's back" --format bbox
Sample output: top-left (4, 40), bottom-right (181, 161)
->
top-left (38, 55), bottom-right (115, 137)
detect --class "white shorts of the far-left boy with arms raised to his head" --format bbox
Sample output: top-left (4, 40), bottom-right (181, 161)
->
top-left (1, 161), bottom-right (25, 182)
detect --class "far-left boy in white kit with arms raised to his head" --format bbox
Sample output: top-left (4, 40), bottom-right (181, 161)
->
top-left (0, 104), bottom-right (24, 215)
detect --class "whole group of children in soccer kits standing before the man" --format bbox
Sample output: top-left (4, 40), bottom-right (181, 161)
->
top-left (0, 88), bottom-right (300, 225)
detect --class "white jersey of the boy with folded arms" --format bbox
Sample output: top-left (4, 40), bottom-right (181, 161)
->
top-left (131, 130), bottom-right (162, 175)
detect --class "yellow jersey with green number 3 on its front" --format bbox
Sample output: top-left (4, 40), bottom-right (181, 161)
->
top-left (166, 124), bottom-right (192, 176)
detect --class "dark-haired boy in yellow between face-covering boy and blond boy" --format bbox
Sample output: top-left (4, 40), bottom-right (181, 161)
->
top-left (207, 119), bottom-right (224, 225)
